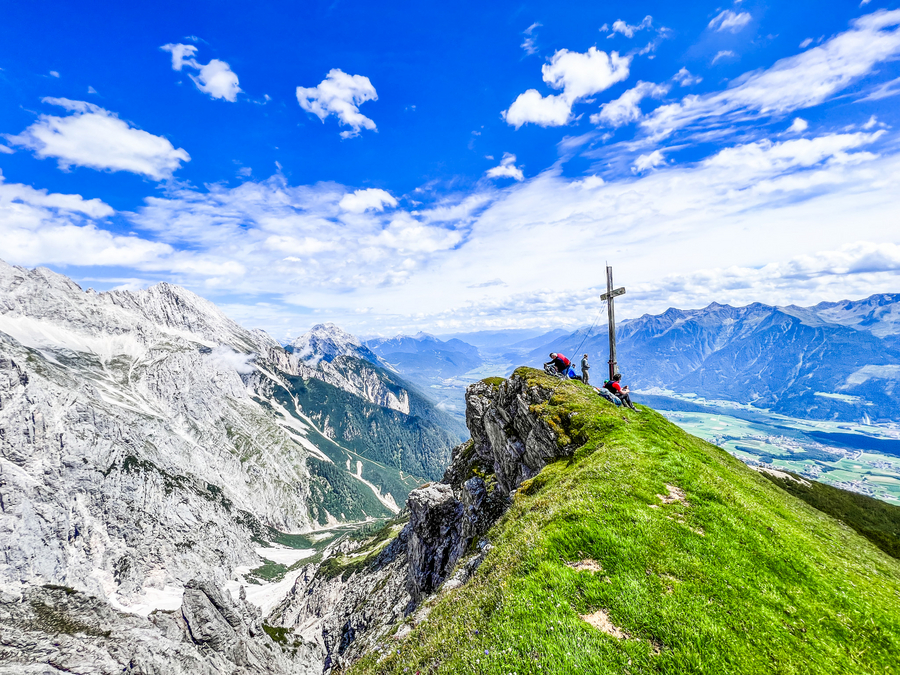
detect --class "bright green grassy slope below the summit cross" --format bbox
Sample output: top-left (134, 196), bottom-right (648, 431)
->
top-left (352, 369), bottom-right (900, 675)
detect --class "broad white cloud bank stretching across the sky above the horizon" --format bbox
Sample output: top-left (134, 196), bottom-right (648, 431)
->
top-left (12, 123), bottom-right (900, 334)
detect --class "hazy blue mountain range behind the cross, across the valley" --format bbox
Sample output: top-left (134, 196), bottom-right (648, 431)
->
top-left (527, 294), bottom-right (900, 421)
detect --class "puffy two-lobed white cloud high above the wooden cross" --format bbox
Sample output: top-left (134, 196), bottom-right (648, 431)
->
top-left (502, 47), bottom-right (631, 129)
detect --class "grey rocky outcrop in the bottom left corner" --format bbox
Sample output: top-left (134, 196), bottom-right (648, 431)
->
top-left (0, 582), bottom-right (302, 675)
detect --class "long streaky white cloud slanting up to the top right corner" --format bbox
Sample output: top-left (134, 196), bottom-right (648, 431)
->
top-left (641, 10), bottom-right (900, 140)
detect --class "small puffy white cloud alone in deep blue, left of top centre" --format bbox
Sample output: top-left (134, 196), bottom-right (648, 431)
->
top-left (297, 68), bottom-right (378, 138)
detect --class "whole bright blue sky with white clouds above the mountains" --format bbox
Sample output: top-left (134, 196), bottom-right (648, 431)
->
top-left (0, 0), bottom-right (900, 337)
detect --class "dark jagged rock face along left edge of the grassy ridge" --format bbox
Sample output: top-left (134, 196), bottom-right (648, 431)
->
top-left (268, 373), bottom-right (574, 672)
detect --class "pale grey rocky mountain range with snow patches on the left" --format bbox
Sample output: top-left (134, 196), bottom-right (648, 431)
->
top-left (0, 262), bottom-right (463, 632)
